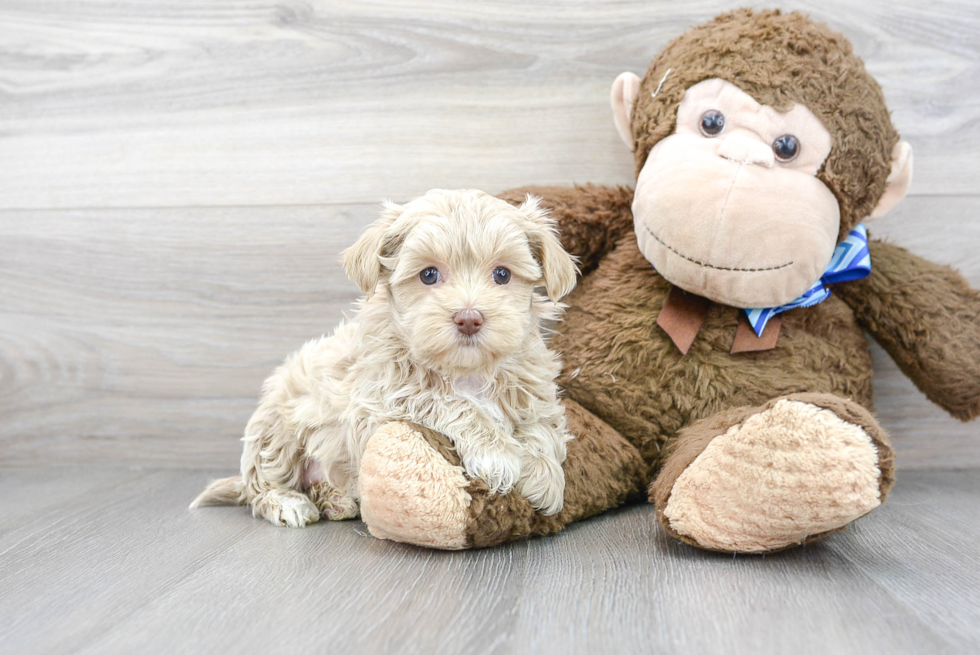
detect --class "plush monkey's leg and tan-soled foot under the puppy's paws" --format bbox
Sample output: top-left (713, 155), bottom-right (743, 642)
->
top-left (360, 400), bottom-right (647, 549)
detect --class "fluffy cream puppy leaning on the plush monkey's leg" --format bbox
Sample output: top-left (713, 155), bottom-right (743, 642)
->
top-left (191, 190), bottom-right (577, 527)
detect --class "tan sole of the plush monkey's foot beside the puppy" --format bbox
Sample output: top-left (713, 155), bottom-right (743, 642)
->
top-left (360, 423), bottom-right (472, 550)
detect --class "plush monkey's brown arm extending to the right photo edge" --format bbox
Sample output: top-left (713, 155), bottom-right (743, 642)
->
top-left (834, 241), bottom-right (980, 421)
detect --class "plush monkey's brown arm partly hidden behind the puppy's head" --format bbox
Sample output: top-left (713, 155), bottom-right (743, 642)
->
top-left (500, 184), bottom-right (633, 275)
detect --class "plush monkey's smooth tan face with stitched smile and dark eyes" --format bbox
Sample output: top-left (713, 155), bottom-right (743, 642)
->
top-left (633, 79), bottom-right (840, 308)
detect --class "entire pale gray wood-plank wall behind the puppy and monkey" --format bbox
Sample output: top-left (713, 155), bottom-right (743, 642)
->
top-left (0, 0), bottom-right (980, 469)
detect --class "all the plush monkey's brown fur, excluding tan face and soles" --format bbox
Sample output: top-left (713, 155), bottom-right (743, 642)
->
top-left (360, 10), bottom-right (980, 547)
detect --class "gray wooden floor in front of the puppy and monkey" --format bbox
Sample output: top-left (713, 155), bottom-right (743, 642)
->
top-left (0, 467), bottom-right (980, 655)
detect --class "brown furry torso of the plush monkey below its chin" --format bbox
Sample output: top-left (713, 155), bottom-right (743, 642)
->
top-left (520, 187), bottom-right (871, 472)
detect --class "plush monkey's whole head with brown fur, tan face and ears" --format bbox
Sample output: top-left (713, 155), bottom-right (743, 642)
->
top-left (612, 9), bottom-right (912, 308)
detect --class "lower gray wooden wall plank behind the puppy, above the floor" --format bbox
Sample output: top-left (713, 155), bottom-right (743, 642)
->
top-left (0, 197), bottom-right (980, 468)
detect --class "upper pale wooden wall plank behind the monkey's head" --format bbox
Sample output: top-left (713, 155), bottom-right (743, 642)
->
top-left (0, 0), bottom-right (980, 208)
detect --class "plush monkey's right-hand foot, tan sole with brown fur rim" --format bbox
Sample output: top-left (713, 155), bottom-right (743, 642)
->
top-left (650, 394), bottom-right (894, 553)
